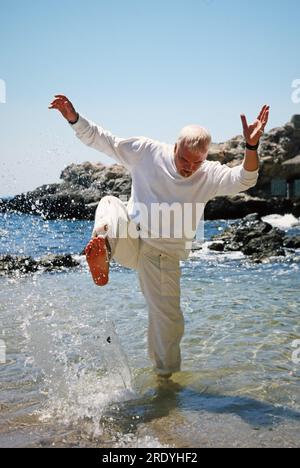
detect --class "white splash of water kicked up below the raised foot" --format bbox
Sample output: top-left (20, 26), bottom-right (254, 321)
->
top-left (22, 311), bottom-right (136, 437)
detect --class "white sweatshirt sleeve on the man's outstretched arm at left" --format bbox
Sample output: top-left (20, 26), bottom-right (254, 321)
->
top-left (70, 115), bottom-right (151, 169)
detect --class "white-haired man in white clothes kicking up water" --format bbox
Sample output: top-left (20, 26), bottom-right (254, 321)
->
top-left (49, 95), bottom-right (269, 378)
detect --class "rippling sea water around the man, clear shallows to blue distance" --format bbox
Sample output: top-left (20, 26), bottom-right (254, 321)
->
top-left (0, 212), bottom-right (300, 447)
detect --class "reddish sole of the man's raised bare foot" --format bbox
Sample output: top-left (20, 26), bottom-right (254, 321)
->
top-left (84, 237), bottom-right (109, 286)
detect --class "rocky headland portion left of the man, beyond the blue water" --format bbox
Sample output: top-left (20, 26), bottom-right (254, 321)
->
top-left (0, 162), bottom-right (131, 220)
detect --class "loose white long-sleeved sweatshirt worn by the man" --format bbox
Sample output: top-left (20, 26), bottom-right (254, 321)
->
top-left (72, 115), bottom-right (259, 260)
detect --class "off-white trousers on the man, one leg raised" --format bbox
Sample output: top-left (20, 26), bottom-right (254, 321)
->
top-left (93, 196), bottom-right (184, 375)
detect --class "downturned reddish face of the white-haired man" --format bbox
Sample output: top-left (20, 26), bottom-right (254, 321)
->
top-left (174, 143), bottom-right (208, 177)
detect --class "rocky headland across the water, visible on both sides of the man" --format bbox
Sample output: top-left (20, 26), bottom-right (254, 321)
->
top-left (0, 115), bottom-right (300, 220)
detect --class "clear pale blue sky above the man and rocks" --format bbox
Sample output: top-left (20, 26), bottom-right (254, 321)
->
top-left (0, 0), bottom-right (300, 196)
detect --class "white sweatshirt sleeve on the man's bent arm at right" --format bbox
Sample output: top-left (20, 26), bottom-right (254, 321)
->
top-left (213, 162), bottom-right (259, 197)
